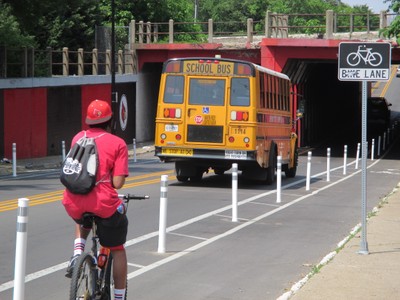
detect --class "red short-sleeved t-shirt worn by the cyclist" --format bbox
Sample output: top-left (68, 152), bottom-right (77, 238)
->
top-left (62, 128), bottom-right (129, 219)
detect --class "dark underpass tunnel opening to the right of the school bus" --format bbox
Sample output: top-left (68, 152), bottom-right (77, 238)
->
top-left (282, 59), bottom-right (361, 154)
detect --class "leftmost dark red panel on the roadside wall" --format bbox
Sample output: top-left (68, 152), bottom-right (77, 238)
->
top-left (4, 88), bottom-right (47, 159)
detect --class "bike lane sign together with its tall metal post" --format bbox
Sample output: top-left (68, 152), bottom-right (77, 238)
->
top-left (338, 42), bottom-right (391, 254)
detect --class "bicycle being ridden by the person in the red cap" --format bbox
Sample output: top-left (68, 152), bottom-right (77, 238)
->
top-left (69, 194), bottom-right (149, 300)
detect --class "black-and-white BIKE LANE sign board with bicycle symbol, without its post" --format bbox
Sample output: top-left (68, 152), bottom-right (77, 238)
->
top-left (338, 42), bottom-right (391, 81)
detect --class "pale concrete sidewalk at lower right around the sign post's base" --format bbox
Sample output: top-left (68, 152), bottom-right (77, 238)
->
top-left (279, 184), bottom-right (400, 300)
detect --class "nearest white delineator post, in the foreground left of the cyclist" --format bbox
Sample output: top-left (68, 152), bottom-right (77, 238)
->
top-left (13, 198), bottom-right (29, 300)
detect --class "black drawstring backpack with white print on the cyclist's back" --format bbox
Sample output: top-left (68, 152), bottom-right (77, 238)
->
top-left (60, 131), bottom-right (106, 194)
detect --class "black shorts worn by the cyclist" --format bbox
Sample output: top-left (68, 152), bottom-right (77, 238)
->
top-left (75, 211), bottom-right (128, 247)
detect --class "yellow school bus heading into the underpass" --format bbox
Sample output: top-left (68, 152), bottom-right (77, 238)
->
top-left (155, 57), bottom-right (298, 184)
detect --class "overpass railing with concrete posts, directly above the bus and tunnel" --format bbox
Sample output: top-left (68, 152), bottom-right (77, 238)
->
top-left (130, 10), bottom-right (395, 44)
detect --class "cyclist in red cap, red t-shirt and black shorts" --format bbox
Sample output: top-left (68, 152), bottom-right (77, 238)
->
top-left (62, 100), bottom-right (129, 300)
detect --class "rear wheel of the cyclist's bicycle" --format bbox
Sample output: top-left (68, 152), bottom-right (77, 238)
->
top-left (69, 253), bottom-right (97, 300)
